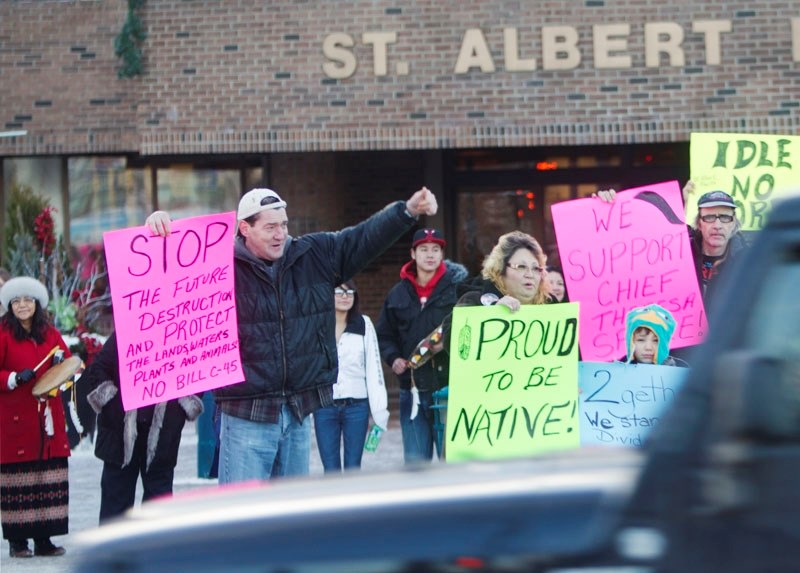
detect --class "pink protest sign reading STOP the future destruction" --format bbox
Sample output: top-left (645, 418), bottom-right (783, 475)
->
top-left (103, 212), bottom-right (244, 410)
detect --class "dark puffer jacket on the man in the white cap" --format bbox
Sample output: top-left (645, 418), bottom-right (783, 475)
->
top-left (214, 201), bottom-right (415, 401)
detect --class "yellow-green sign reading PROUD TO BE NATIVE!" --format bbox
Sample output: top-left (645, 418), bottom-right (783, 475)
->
top-left (445, 303), bottom-right (580, 462)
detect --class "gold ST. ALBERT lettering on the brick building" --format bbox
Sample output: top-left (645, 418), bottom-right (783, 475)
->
top-left (322, 17), bottom-right (800, 79)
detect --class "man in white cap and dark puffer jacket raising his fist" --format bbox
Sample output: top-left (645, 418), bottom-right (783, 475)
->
top-left (147, 187), bottom-right (437, 484)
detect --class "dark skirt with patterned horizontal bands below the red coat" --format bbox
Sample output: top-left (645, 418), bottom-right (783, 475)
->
top-left (0, 458), bottom-right (69, 539)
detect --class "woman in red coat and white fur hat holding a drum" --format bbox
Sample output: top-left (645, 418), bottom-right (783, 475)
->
top-left (0, 277), bottom-right (69, 557)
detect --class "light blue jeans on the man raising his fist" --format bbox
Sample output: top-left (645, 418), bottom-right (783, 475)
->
top-left (219, 404), bottom-right (311, 484)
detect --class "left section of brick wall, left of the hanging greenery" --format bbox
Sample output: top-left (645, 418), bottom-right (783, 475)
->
top-left (0, 1), bottom-right (141, 155)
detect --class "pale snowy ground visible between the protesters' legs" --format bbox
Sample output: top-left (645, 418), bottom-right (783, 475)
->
top-left (0, 419), bottom-right (403, 573)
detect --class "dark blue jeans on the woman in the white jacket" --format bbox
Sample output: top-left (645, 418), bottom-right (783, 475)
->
top-left (314, 398), bottom-right (369, 473)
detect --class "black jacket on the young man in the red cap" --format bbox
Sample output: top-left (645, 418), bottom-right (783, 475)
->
top-left (375, 261), bottom-right (469, 391)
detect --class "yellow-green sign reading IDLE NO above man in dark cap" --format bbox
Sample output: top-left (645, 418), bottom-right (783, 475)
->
top-left (686, 133), bottom-right (800, 231)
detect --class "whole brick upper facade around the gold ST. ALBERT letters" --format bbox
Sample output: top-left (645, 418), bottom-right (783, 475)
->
top-left (0, 0), bottom-right (800, 155)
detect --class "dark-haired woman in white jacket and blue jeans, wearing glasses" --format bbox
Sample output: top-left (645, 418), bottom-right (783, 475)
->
top-left (314, 281), bottom-right (389, 473)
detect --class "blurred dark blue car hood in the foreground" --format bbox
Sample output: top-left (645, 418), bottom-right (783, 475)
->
top-left (70, 448), bottom-right (643, 571)
